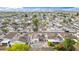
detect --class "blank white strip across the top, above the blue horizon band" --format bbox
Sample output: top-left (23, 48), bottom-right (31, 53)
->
top-left (0, 0), bottom-right (79, 8)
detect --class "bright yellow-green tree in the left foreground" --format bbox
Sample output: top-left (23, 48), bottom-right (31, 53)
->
top-left (6, 43), bottom-right (31, 51)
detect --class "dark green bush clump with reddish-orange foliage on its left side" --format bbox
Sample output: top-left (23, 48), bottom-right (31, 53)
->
top-left (54, 39), bottom-right (76, 51)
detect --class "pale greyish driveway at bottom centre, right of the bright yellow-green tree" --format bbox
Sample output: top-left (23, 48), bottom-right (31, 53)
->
top-left (30, 42), bottom-right (53, 51)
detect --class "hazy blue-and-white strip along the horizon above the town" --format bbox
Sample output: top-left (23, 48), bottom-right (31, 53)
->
top-left (0, 7), bottom-right (79, 12)
